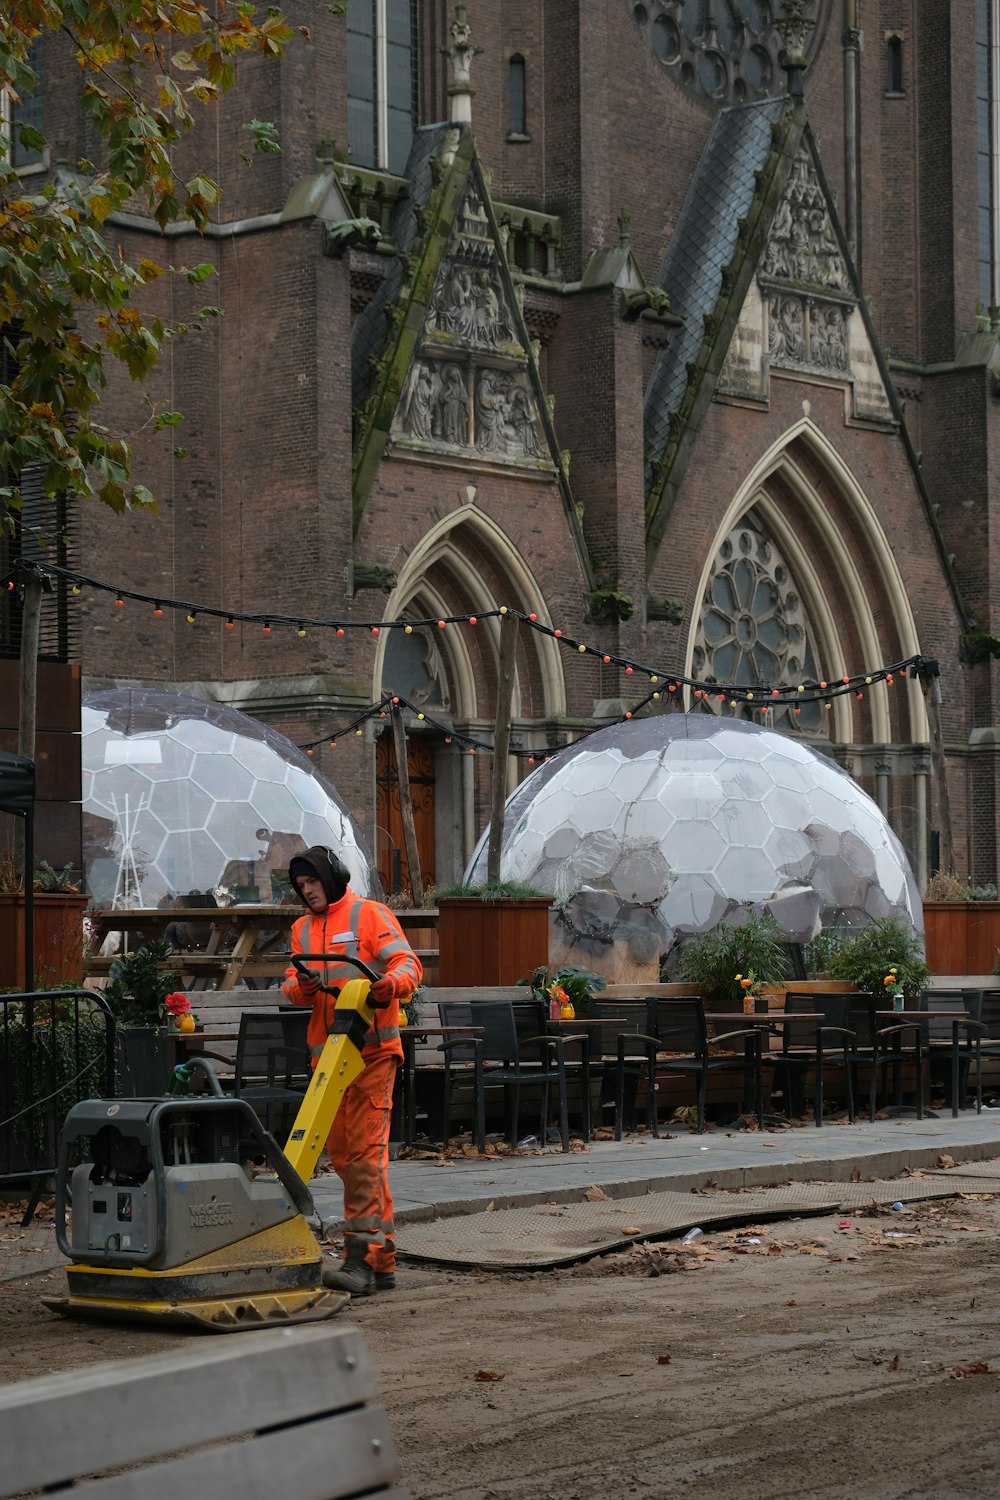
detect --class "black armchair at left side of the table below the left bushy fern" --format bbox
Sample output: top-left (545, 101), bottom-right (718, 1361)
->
top-left (630, 996), bottom-right (763, 1131)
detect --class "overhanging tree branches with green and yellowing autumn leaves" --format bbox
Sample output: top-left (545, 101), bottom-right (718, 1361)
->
top-left (0, 0), bottom-right (299, 525)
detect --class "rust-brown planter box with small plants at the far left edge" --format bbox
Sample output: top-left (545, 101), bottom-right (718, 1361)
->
top-left (0, 848), bottom-right (87, 990)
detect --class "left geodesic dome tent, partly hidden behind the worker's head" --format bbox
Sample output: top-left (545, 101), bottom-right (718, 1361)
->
top-left (82, 689), bottom-right (381, 906)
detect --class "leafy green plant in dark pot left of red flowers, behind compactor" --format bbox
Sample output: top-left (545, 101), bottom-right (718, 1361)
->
top-left (103, 942), bottom-right (190, 1098)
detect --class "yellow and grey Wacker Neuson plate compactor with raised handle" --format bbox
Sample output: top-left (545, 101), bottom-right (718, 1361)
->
top-left (48, 954), bottom-right (378, 1334)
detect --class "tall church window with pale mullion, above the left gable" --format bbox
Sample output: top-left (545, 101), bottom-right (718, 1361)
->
top-left (348, 0), bottom-right (417, 176)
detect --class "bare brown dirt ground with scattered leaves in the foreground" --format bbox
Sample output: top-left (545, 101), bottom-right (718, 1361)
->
top-left (0, 1197), bottom-right (1000, 1500)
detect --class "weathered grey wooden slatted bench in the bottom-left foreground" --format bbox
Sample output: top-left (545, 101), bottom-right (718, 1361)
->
top-left (0, 1323), bottom-right (409, 1500)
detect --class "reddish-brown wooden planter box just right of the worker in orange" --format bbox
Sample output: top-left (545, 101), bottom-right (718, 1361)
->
top-left (438, 896), bottom-right (552, 986)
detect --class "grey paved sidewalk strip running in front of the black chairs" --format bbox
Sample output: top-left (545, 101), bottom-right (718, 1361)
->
top-left (312, 1109), bottom-right (1000, 1227)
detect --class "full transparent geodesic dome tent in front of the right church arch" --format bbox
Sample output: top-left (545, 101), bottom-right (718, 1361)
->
top-left (466, 714), bottom-right (924, 966)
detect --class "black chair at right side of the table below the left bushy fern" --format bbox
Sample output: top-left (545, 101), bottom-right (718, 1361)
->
top-left (769, 990), bottom-right (855, 1125)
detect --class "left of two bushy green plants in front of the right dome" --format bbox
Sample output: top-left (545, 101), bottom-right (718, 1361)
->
top-left (670, 903), bottom-right (792, 1011)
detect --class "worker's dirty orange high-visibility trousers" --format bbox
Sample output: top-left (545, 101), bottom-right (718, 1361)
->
top-left (327, 1052), bottom-right (399, 1271)
